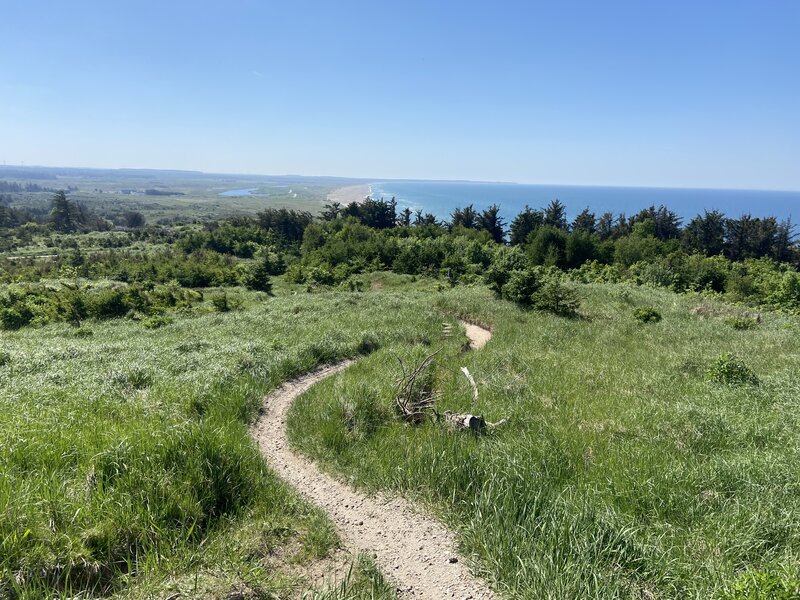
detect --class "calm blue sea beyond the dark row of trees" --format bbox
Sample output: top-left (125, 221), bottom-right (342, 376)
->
top-left (372, 181), bottom-right (800, 221)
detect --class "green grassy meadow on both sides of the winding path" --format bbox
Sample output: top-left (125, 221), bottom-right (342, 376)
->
top-left (0, 274), bottom-right (800, 600)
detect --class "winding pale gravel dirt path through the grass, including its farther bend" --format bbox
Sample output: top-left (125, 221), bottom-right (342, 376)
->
top-left (253, 324), bottom-right (496, 600)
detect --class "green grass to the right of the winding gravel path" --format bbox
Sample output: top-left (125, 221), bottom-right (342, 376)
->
top-left (289, 285), bottom-right (800, 598)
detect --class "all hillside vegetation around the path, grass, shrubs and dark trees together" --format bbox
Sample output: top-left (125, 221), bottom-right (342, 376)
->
top-left (0, 187), bottom-right (800, 598)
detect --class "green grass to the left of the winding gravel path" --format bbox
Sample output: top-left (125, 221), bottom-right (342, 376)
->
top-left (0, 284), bottom-right (444, 598)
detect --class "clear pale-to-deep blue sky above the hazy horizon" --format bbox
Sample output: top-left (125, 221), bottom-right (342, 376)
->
top-left (0, 0), bottom-right (800, 190)
